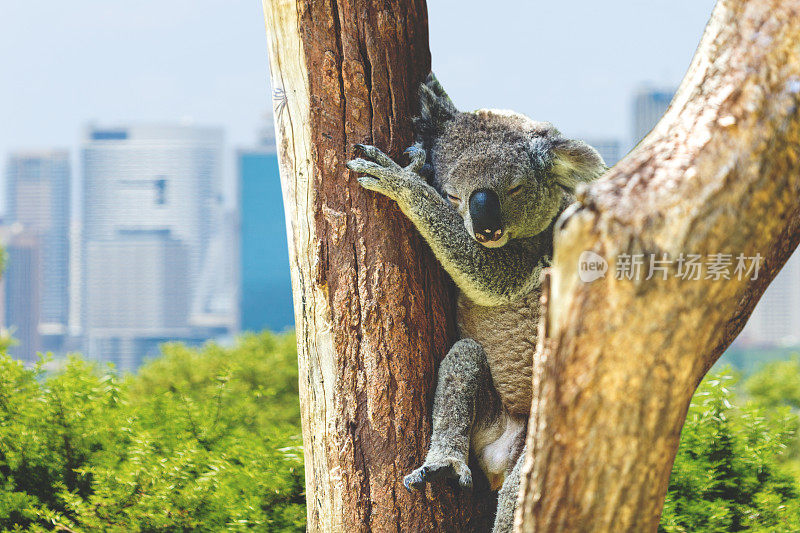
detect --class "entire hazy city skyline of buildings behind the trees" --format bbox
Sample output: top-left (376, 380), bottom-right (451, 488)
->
top-left (0, 85), bottom-right (800, 370)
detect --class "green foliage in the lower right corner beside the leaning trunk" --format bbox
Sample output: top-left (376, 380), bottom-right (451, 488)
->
top-left (659, 374), bottom-right (800, 533)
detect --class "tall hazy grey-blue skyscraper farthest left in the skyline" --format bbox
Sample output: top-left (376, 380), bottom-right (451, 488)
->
top-left (6, 150), bottom-right (70, 351)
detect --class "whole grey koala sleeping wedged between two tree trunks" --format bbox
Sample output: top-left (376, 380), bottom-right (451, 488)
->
top-left (347, 74), bottom-right (606, 533)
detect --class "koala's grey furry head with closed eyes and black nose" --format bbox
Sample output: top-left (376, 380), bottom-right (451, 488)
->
top-left (416, 81), bottom-right (606, 248)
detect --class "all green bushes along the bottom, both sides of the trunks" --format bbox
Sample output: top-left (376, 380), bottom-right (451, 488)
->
top-left (0, 333), bottom-right (800, 533)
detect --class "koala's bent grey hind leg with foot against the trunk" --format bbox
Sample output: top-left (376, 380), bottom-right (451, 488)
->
top-left (403, 339), bottom-right (491, 490)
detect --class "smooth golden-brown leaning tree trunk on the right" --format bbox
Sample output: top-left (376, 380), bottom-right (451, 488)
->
top-left (516, 0), bottom-right (800, 532)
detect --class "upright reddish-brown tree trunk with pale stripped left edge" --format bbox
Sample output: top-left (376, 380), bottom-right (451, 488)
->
top-left (263, 0), bottom-right (491, 531)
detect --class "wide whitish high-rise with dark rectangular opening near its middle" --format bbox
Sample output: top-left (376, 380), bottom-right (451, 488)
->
top-left (81, 125), bottom-right (222, 368)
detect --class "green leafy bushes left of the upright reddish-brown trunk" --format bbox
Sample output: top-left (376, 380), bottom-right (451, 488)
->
top-left (0, 333), bottom-right (305, 532)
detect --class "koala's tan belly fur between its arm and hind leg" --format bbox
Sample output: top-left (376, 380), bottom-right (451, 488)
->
top-left (458, 288), bottom-right (541, 417)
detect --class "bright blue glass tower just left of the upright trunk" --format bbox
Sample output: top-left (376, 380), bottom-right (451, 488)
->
top-left (237, 127), bottom-right (294, 331)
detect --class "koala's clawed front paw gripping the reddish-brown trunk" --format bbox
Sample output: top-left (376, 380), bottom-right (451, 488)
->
top-left (347, 144), bottom-right (425, 200)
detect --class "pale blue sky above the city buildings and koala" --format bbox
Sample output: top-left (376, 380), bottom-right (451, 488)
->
top-left (0, 0), bottom-right (714, 206)
